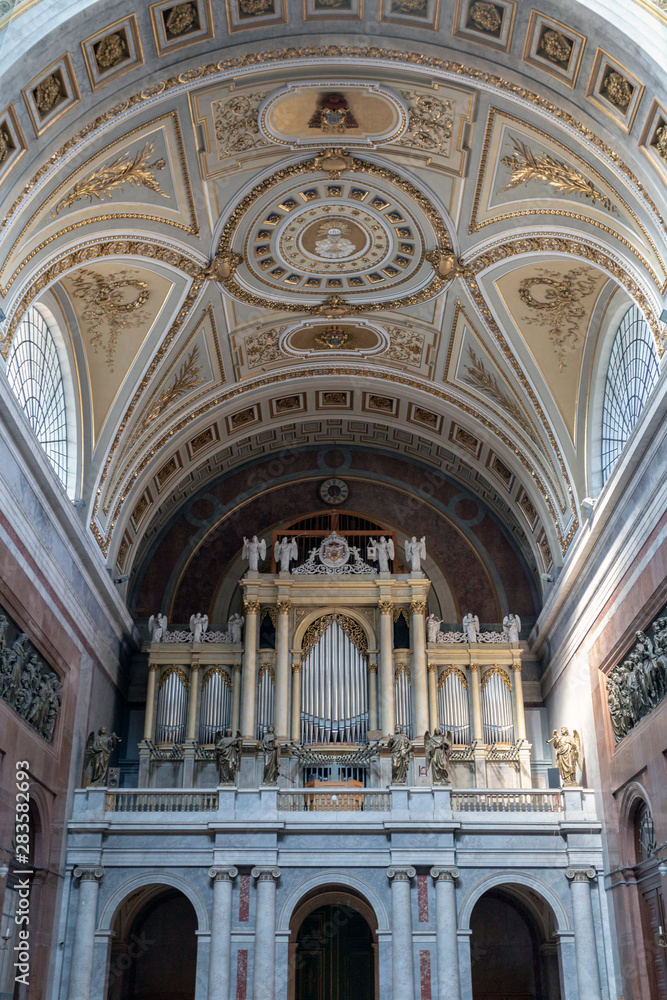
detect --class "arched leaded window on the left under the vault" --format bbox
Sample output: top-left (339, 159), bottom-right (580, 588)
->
top-left (7, 306), bottom-right (72, 489)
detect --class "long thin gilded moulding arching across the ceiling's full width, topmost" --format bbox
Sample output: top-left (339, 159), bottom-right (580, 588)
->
top-left (0, 46), bottom-right (667, 250)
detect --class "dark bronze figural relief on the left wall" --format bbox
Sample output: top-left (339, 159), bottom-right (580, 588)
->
top-left (0, 608), bottom-right (62, 743)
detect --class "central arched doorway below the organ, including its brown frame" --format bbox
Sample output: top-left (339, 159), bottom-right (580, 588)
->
top-left (289, 889), bottom-right (378, 1000)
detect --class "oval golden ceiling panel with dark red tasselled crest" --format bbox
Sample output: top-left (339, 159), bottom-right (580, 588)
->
top-left (258, 80), bottom-right (408, 149)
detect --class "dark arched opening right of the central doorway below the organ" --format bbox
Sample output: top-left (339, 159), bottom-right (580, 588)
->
top-left (470, 886), bottom-right (561, 1000)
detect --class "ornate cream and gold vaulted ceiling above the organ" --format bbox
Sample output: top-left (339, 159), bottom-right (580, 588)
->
top-left (0, 0), bottom-right (667, 604)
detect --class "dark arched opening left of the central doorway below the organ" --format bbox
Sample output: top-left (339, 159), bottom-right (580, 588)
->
top-left (106, 885), bottom-right (197, 1000)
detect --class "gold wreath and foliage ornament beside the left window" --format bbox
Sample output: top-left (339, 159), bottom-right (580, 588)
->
top-left (72, 268), bottom-right (150, 372)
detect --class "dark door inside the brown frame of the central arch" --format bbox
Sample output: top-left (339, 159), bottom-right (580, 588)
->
top-left (295, 905), bottom-right (375, 1000)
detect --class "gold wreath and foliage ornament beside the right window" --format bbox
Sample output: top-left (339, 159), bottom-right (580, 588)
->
top-left (519, 267), bottom-right (603, 369)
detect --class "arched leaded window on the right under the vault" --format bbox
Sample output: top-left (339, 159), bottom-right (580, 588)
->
top-left (602, 306), bottom-right (660, 484)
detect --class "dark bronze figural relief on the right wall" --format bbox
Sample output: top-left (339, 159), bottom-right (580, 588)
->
top-left (607, 618), bottom-right (667, 743)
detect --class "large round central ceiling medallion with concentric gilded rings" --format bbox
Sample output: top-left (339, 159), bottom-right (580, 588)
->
top-left (218, 157), bottom-right (450, 311)
